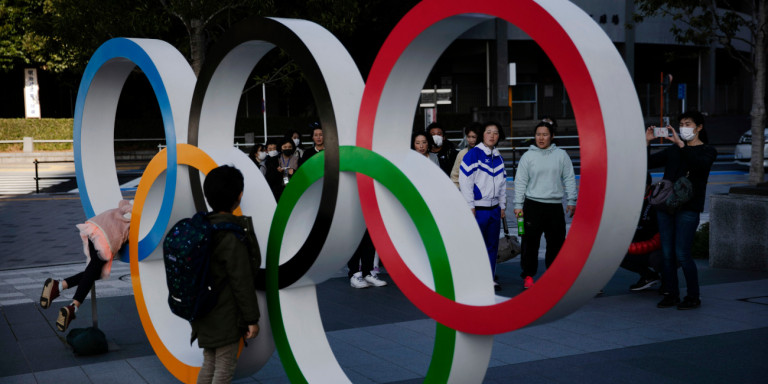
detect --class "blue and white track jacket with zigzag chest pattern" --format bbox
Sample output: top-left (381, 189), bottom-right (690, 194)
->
top-left (459, 143), bottom-right (507, 210)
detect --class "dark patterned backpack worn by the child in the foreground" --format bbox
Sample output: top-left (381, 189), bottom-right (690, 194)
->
top-left (163, 212), bottom-right (245, 321)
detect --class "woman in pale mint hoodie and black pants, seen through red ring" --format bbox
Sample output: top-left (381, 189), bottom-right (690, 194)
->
top-left (515, 121), bottom-right (576, 289)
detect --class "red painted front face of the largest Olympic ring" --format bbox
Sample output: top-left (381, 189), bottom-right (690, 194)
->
top-left (357, 0), bottom-right (607, 335)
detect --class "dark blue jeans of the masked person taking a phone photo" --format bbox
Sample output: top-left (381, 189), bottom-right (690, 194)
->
top-left (657, 210), bottom-right (699, 299)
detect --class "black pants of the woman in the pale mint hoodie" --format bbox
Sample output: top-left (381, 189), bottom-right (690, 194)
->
top-left (520, 199), bottom-right (565, 278)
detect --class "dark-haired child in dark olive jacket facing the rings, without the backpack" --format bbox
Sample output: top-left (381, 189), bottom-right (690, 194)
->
top-left (190, 165), bottom-right (261, 383)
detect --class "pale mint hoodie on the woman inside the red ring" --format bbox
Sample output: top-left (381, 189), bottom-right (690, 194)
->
top-left (515, 144), bottom-right (577, 209)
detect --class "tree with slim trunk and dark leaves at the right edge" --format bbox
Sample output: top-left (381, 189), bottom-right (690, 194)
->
top-left (635, 0), bottom-right (768, 184)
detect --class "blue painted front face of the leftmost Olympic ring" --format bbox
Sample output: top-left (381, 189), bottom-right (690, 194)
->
top-left (73, 38), bottom-right (177, 263)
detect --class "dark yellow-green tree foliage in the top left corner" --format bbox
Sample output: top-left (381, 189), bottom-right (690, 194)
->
top-left (0, 0), bottom-right (170, 73)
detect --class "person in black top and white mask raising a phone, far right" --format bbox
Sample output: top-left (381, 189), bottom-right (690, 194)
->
top-left (645, 111), bottom-right (717, 309)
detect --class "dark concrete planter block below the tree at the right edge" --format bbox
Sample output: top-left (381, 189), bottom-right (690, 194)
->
top-left (709, 194), bottom-right (768, 271)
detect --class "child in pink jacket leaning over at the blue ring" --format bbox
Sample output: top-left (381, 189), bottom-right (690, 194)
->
top-left (40, 200), bottom-right (133, 332)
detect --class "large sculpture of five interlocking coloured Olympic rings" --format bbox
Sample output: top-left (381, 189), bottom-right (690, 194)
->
top-left (74, 0), bottom-right (646, 383)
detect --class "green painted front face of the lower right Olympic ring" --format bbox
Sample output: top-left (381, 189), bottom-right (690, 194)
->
top-left (266, 146), bottom-right (456, 383)
